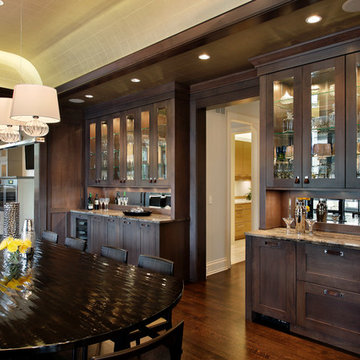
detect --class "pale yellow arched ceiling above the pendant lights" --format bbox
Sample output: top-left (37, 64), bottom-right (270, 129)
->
top-left (0, 0), bottom-right (249, 88)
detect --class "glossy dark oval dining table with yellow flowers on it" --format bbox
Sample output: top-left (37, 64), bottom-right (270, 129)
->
top-left (0, 241), bottom-right (183, 358)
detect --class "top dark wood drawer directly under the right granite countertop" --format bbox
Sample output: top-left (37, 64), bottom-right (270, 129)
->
top-left (297, 243), bottom-right (360, 293)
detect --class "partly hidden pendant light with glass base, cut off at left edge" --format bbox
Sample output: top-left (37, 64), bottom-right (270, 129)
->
top-left (0, 98), bottom-right (22, 143)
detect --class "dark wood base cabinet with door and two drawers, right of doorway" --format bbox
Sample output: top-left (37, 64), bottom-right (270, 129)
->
top-left (246, 230), bottom-right (360, 354)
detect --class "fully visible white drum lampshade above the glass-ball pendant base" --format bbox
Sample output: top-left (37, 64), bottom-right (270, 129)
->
top-left (10, 84), bottom-right (60, 123)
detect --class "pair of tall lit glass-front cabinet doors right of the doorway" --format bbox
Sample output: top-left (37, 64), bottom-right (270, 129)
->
top-left (266, 56), bottom-right (345, 188)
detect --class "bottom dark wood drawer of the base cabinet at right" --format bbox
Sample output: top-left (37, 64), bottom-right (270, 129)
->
top-left (294, 281), bottom-right (360, 353)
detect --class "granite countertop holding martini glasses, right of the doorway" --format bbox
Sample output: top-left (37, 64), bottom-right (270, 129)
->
top-left (245, 228), bottom-right (360, 249)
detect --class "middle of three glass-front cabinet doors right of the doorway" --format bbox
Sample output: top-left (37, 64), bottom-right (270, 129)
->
top-left (302, 57), bottom-right (345, 187)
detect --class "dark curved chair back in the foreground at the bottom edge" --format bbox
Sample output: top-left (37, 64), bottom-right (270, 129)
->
top-left (92, 321), bottom-right (184, 360)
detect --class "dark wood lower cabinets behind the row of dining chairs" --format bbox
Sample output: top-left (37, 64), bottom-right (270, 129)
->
top-left (71, 212), bottom-right (188, 279)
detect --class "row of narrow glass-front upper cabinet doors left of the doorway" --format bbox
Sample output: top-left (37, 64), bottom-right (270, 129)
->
top-left (86, 100), bottom-right (174, 187)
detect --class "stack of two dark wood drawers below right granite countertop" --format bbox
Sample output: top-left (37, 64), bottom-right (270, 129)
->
top-left (293, 243), bottom-right (360, 353)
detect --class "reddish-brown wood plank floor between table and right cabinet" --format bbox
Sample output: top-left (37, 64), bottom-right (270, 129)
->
top-left (173, 263), bottom-right (359, 360)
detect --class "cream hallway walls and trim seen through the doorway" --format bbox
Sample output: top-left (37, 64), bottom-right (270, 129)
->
top-left (206, 98), bottom-right (260, 276)
